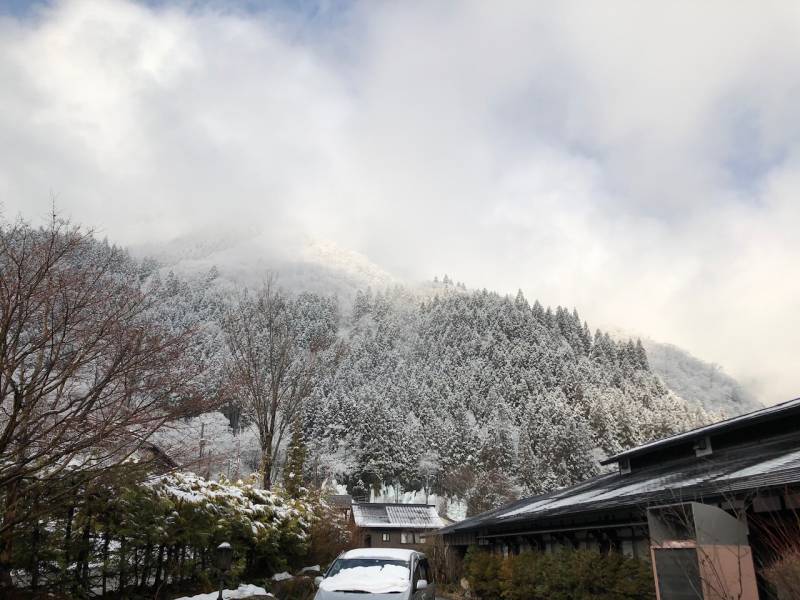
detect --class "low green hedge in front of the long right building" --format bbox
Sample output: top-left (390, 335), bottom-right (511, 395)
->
top-left (464, 547), bottom-right (655, 600)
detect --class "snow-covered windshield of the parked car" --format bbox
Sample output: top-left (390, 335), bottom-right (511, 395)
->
top-left (320, 558), bottom-right (411, 594)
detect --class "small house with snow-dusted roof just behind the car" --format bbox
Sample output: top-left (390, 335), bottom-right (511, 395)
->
top-left (351, 502), bottom-right (445, 548)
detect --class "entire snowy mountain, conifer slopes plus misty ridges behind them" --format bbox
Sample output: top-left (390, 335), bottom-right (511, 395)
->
top-left (123, 230), bottom-right (768, 513)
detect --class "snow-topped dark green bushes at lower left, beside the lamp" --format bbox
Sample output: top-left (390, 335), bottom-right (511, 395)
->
top-left (9, 473), bottom-right (323, 597)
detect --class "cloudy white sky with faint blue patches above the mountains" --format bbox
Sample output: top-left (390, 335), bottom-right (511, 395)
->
top-left (0, 0), bottom-right (800, 403)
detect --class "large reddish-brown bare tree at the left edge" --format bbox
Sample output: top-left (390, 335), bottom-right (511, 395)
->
top-left (0, 216), bottom-right (206, 581)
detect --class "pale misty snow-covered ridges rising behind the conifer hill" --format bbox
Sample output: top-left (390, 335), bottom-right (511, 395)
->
top-left (138, 227), bottom-right (761, 415)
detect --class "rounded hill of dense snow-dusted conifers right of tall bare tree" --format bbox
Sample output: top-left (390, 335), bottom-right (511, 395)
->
top-left (305, 283), bottom-right (705, 508)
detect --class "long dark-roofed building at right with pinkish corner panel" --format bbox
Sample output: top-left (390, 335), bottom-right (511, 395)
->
top-left (439, 399), bottom-right (800, 600)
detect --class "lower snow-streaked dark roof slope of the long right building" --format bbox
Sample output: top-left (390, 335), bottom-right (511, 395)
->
top-left (440, 435), bottom-right (800, 534)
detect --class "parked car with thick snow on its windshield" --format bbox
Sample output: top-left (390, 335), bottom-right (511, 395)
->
top-left (314, 548), bottom-right (436, 600)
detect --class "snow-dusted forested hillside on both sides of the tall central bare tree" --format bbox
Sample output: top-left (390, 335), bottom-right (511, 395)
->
top-left (42, 234), bottom-right (708, 512)
